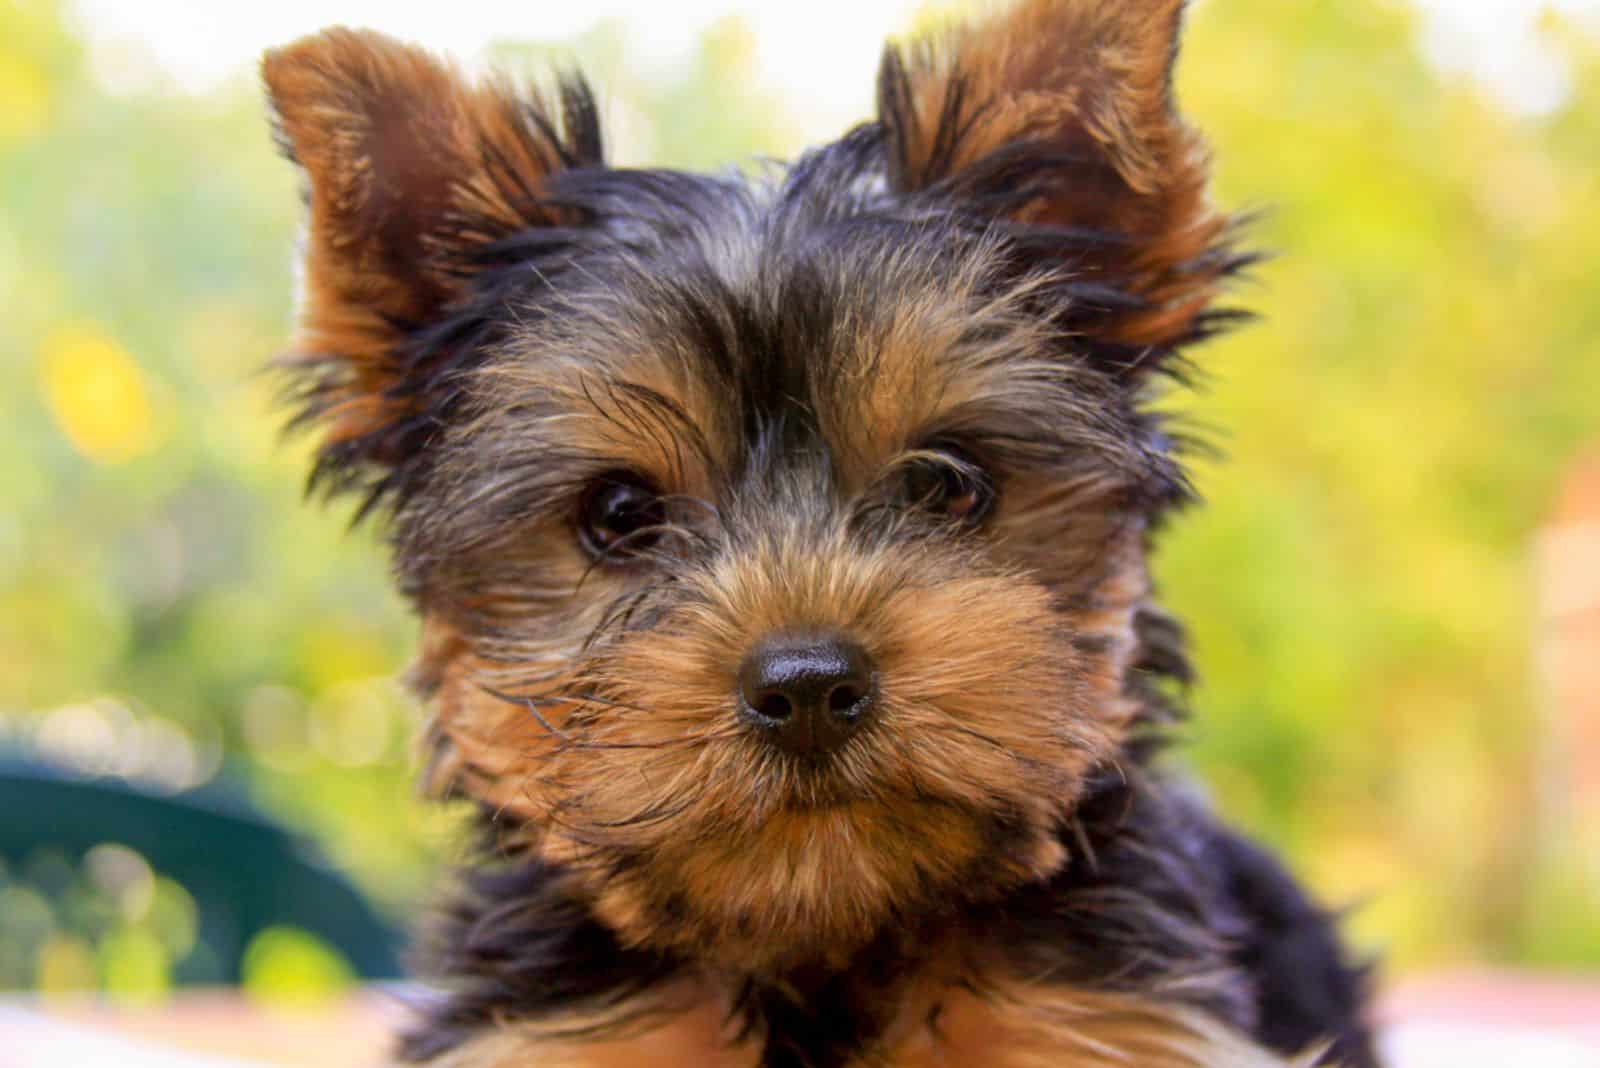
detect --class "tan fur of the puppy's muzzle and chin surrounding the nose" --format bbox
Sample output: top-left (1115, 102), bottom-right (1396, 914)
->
top-left (412, 511), bottom-right (1125, 966)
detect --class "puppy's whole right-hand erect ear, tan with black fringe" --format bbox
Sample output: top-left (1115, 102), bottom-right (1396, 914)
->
top-left (878, 0), bottom-right (1250, 371)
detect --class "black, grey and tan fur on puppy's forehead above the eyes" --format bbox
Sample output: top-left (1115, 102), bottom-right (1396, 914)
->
top-left (409, 214), bottom-right (1182, 552)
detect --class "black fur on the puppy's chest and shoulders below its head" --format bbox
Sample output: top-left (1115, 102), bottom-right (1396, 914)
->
top-left (402, 774), bottom-right (1378, 1068)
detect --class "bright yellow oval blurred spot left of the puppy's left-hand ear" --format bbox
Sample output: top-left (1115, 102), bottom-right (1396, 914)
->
top-left (38, 326), bottom-right (157, 464)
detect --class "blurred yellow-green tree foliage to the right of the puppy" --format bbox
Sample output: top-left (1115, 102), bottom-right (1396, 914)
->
top-left (1160, 2), bottom-right (1600, 962)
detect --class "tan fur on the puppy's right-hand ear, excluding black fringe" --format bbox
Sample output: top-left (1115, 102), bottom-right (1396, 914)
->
top-left (901, 0), bottom-right (1227, 345)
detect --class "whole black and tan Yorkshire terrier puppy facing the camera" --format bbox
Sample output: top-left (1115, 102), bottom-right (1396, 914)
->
top-left (264, 0), bottom-right (1376, 1068)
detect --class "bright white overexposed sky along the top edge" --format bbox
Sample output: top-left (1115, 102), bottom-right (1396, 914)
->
top-left (74, 0), bottom-right (1600, 136)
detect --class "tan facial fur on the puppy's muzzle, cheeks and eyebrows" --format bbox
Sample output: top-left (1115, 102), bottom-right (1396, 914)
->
top-left (403, 280), bottom-right (1149, 967)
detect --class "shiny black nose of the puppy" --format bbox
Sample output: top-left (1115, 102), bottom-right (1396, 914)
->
top-left (739, 635), bottom-right (877, 755)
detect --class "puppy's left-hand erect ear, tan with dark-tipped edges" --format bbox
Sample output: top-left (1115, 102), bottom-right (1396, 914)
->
top-left (261, 29), bottom-right (602, 508)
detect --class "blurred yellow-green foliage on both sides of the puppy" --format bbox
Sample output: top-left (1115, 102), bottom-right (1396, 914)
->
top-left (0, 0), bottom-right (1600, 991)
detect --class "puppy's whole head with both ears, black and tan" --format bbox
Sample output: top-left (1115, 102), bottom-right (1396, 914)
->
top-left (266, 0), bottom-right (1242, 969)
